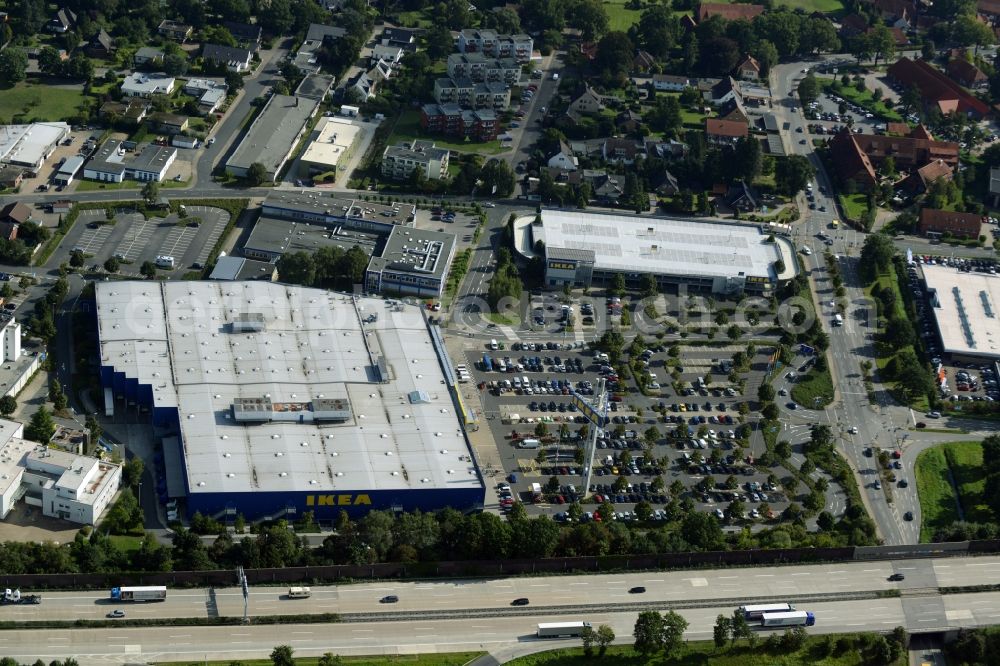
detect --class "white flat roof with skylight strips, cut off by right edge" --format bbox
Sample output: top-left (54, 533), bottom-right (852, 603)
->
top-left (923, 265), bottom-right (1000, 359)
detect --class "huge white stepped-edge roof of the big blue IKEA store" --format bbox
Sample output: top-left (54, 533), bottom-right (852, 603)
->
top-left (97, 281), bottom-right (481, 493)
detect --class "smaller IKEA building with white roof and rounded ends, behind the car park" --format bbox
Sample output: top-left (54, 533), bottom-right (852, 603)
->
top-left (514, 210), bottom-right (798, 294)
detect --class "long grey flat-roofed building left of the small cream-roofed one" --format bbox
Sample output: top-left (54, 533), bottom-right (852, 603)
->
top-left (226, 95), bottom-right (319, 181)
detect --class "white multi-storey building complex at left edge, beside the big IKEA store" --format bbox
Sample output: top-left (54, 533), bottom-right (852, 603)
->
top-left (0, 419), bottom-right (122, 525)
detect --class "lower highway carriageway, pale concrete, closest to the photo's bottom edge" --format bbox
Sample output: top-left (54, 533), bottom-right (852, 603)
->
top-left (0, 593), bottom-right (1000, 666)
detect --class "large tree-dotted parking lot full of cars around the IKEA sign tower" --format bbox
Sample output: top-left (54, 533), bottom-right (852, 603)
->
top-left (464, 314), bottom-right (804, 529)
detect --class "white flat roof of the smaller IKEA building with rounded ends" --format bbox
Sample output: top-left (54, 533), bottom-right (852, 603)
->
top-left (532, 210), bottom-right (781, 279)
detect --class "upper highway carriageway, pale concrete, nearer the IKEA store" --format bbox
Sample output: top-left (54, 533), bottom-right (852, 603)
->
top-left (7, 557), bottom-right (1000, 621)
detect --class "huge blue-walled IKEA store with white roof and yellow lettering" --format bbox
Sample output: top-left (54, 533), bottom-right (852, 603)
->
top-left (96, 281), bottom-right (485, 520)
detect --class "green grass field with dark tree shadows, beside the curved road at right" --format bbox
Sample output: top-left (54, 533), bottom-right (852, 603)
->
top-left (917, 442), bottom-right (993, 541)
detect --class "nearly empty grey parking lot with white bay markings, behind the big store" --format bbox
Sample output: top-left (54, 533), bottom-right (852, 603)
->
top-left (66, 206), bottom-right (229, 272)
